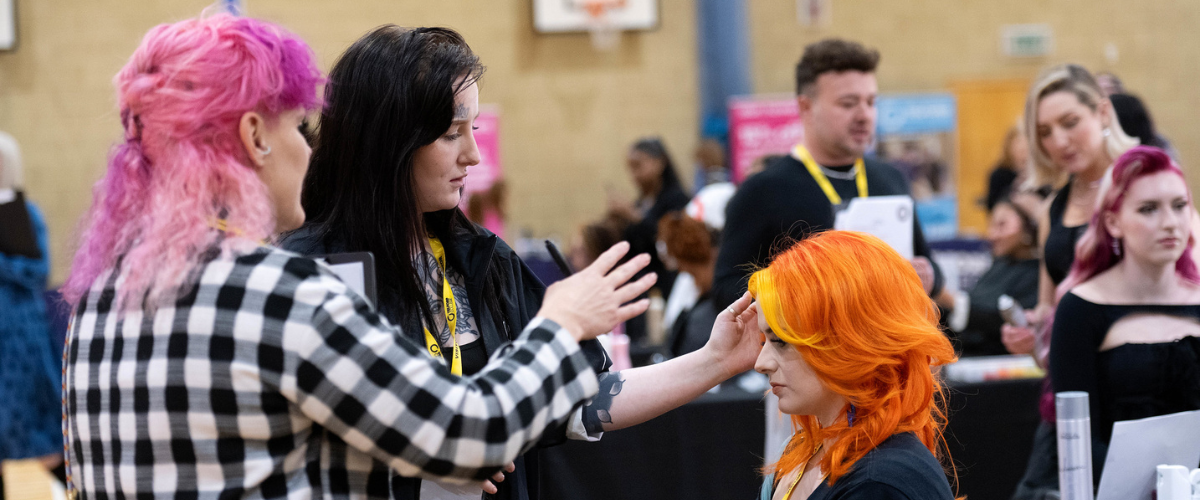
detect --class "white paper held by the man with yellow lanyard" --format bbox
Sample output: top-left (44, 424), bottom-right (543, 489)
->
top-left (834, 195), bottom-right (913, 260)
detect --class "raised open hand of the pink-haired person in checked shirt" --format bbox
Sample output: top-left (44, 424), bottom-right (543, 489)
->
top-left (538, 241), bottom-right (658, 341)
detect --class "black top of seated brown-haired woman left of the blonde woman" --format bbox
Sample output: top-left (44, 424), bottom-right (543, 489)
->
top-left (956, 257), bottom-right (1039, 356)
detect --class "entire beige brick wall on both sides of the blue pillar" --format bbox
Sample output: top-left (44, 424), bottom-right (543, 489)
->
top-left (9, 0), bottom-right (1200, 281)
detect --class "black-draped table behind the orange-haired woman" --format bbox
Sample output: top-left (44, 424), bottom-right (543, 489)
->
top-left (541, 380), bottom-right (1040, 500)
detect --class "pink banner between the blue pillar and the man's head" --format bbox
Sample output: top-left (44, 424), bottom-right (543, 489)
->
top-left (728, 95), bottom-right (804, 182)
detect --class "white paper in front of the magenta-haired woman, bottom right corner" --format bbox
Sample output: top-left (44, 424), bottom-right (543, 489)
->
top-left (1096, 410), bottom-right (1200, 500)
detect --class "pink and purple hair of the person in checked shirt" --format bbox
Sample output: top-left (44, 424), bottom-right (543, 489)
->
top-left (64, 14), bottom-right (323, 308)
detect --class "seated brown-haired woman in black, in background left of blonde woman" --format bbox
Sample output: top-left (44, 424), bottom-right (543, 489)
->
top-left (943, 194), bottom-right (1040, 356)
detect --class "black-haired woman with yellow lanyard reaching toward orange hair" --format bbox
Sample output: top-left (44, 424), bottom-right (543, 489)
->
top-left (283, 25), bottom-right (756, 500)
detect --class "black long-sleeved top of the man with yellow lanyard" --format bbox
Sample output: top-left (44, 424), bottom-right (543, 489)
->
top-left (713, 156), bottom-right (943, 308)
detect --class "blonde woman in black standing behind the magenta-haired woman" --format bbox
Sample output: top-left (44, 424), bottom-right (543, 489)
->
top-left (1001, 65), bottom-right (1138, 500)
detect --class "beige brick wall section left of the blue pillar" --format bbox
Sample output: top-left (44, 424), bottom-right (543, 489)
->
top-left (0, 0), bottom-right (698, 282)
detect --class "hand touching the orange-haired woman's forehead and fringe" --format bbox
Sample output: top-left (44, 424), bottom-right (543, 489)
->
top-left (703, 293), bottom-right (763, 379)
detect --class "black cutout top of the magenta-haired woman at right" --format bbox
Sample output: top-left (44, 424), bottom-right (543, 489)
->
top-left (1050, 293), bottom-right (1200, 477)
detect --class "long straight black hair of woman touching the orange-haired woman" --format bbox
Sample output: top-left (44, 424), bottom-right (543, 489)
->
top-left (301, 25), bottom-right (511, 335)
